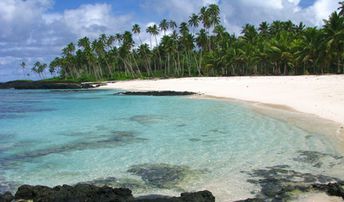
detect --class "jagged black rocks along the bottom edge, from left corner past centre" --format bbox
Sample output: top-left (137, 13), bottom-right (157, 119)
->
top-left (0, 184), bottom-right (215, 202)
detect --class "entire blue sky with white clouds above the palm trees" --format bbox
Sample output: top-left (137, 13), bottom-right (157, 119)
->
top-left (0, 0), bottom-right (340, 82)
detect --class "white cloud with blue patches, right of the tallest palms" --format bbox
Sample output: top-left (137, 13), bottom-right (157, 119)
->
top-left (220, 0), bottom-right (339, 34)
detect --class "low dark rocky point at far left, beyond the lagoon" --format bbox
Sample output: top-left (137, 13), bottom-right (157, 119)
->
top-left (0, 81), bottom-right (103, 89)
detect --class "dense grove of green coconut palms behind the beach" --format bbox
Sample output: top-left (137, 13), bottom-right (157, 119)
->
top-left (28, 2), bottom-right (344, 81)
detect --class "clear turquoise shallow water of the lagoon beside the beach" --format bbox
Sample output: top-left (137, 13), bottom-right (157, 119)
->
top-left (0, 90), bottom-right (344, 201)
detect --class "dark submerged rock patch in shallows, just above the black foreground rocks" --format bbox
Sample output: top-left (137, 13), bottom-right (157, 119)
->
top-left (128, 164), bottom-right (201, 189)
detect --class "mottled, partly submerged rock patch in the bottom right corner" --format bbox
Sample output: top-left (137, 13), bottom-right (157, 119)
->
top-left (243, 165), bottom-right (344, 201)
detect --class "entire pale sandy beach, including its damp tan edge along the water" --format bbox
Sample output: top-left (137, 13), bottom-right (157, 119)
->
top-left (98, 75), bottom-right (344, 148)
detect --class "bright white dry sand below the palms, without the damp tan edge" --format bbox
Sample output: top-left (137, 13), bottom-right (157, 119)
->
top-left (101, 75), bottom-right (344, 125)
